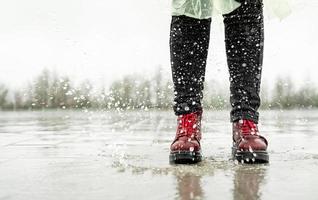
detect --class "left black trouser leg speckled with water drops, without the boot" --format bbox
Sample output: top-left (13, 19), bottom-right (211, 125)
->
top-left (170, 16), bottom-right (211, 115)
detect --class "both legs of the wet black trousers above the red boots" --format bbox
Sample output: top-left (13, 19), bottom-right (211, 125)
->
top-left (170, 0), bottom-right (264, 123)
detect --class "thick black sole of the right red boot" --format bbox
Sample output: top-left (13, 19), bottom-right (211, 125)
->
top-left (232, 147), bottom-right (269, 164)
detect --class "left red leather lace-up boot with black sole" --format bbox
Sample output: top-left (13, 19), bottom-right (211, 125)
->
top-left (169, 111), bottom-right (202, 164)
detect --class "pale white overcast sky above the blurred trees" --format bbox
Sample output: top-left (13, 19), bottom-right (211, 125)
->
top-left (0, 0), bottom-right (318, 87)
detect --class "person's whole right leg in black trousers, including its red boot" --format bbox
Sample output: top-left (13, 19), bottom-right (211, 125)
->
top-left (224, 0), bottom-right (269, 163)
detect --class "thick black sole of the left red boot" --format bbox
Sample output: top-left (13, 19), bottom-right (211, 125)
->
top-left (169, 151), bottom-right (202, 164)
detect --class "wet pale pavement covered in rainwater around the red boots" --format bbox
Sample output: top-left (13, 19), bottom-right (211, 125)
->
top-left (0, 110), bottom-right (318, 200)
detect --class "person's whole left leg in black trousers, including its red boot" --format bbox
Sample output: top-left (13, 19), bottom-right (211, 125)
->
top-left (169, 15), bottom-right (211, 163)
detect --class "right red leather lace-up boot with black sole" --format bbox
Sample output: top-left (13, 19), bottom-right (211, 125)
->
top-left (232, 119), bottom-right (269, 164)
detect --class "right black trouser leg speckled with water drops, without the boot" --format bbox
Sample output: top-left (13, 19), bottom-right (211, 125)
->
top-left (223, 0), bottom-right (264, 123)
